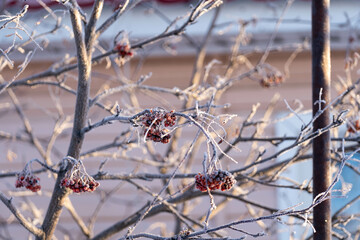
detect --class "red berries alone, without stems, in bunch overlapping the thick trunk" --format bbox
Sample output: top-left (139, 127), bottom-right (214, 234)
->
top-left (61, 177), bottom-right (100, 193)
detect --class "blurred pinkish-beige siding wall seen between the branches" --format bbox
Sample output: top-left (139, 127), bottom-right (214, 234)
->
top-left (0, 49), bottom-right (354, 239)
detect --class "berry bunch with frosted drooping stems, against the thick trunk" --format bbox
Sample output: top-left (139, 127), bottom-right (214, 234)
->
top-left (60, 157), bottom-right (100, 193)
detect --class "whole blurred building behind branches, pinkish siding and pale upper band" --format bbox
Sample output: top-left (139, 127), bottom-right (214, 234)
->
top-left (0, 0), bottom-right (360, 239)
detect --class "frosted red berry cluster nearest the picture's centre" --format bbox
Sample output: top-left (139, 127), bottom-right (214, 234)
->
top-left (141, 110), bottom-right (176, 143)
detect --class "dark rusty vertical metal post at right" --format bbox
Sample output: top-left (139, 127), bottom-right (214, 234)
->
top-left (312, 0), bottom-right (331, 240)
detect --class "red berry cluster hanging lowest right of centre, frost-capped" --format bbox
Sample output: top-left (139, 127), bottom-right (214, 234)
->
top-left (195, 170), bottom-right (236, 192)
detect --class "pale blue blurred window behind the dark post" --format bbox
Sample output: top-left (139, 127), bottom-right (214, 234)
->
top-left (275, 113), bottom-right (360, 240)
